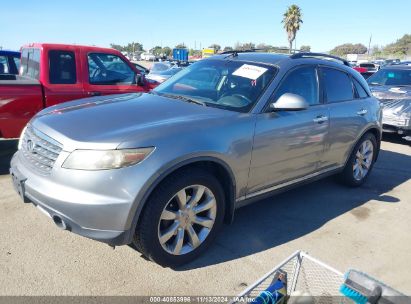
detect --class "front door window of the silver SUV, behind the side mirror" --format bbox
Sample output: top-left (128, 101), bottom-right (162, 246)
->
top-left (274, 66), bottom-right (320, 106)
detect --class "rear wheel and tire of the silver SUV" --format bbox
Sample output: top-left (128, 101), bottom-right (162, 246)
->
top-left (339, 133), bottom-right (378, 187)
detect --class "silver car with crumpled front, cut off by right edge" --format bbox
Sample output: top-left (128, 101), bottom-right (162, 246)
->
top-left (367, 65), bottom-right (411, 137)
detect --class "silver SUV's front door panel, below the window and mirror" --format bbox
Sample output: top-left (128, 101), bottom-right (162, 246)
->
top-left (248, 105), bottom-right (329, 193)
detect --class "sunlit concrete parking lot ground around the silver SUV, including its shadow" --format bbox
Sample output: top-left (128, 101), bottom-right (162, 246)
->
top-left (0, 138), bottom-right (411, 295)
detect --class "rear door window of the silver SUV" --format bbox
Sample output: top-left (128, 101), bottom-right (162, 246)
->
top-left (321, 68), bottom-right (354, 103)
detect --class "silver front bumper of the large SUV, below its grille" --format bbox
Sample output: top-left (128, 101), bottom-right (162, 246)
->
top-left (10, 152), bottom-right (150, 245)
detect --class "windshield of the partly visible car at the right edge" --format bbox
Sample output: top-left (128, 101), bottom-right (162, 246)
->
top-left (367, 69), bottom-right (411, 86)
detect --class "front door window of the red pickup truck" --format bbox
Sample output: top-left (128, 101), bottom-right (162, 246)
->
top-left (88, 53), bottom-right (135, 85)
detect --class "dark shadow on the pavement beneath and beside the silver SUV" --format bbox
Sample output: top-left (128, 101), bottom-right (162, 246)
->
top-left (171, 150), bottom-right (411, 271)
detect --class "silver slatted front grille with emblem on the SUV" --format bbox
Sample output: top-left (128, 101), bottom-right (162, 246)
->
top-left (21, 126), bottom-right (63, 174)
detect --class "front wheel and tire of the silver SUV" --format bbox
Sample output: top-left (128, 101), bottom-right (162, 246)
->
top-left (133, 169), bottom-right (225, 267)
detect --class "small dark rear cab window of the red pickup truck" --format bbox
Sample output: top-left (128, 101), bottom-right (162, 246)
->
top-left (49, 50), bottom-right (77, 84)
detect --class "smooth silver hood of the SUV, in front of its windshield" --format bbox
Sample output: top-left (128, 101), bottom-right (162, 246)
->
top-left (32, 93), bottom-right (236, 151)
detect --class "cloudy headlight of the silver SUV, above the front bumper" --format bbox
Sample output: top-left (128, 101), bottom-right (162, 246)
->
top-left (62, 147), bottom-right (154, 170)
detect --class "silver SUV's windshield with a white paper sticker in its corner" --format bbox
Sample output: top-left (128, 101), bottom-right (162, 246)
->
top-left (154, 60), bottom-right (276, 112)
